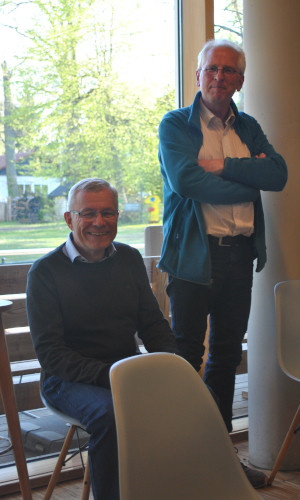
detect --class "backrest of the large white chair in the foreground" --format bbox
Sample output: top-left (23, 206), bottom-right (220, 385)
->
top-left (110, 353), bottom-right (259, 500)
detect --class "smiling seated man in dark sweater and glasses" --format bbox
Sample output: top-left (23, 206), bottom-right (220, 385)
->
top-left (27, 179), bottom-right (179, 500)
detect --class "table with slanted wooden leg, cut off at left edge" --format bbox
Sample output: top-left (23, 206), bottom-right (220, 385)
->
top-left (0, 300), bottom-right (32, 500)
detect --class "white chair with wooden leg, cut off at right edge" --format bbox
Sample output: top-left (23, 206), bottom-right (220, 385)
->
top-left (268, 280), bottom-right (300, 485)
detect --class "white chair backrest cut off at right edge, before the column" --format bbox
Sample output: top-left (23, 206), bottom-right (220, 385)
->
top-left (274, 280), bottom-right (300, 381)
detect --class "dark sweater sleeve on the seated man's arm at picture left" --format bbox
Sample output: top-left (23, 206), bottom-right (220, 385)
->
top-left (27, 259), bottom-right (110, 388)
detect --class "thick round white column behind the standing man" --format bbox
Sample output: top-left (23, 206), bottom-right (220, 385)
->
top-left (244, 0), bottom-right (300, 470)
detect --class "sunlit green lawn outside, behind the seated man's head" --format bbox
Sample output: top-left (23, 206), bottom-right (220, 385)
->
top-left (0, 221), bottom-right (145, 264)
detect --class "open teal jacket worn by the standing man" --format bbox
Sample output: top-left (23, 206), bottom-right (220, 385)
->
top-left (158, 92), bottom-right (287, 284)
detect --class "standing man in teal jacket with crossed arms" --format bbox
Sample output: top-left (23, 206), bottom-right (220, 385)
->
top-left (159, 40), bottom-right (287, 487)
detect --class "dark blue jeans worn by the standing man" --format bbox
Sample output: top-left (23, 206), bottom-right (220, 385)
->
top-left (167, 238), bottom-right (253, 432)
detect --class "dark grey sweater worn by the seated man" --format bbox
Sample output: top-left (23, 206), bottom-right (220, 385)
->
top-left (27, 242), bottom-right (179, 387)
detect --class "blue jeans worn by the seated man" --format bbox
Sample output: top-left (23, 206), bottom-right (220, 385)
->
top-left (43, 376), bottom-right (120, 500)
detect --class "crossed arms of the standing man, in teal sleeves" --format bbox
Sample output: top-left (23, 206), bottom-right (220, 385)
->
top-left (159, 112), bottom-right (287, 204)
